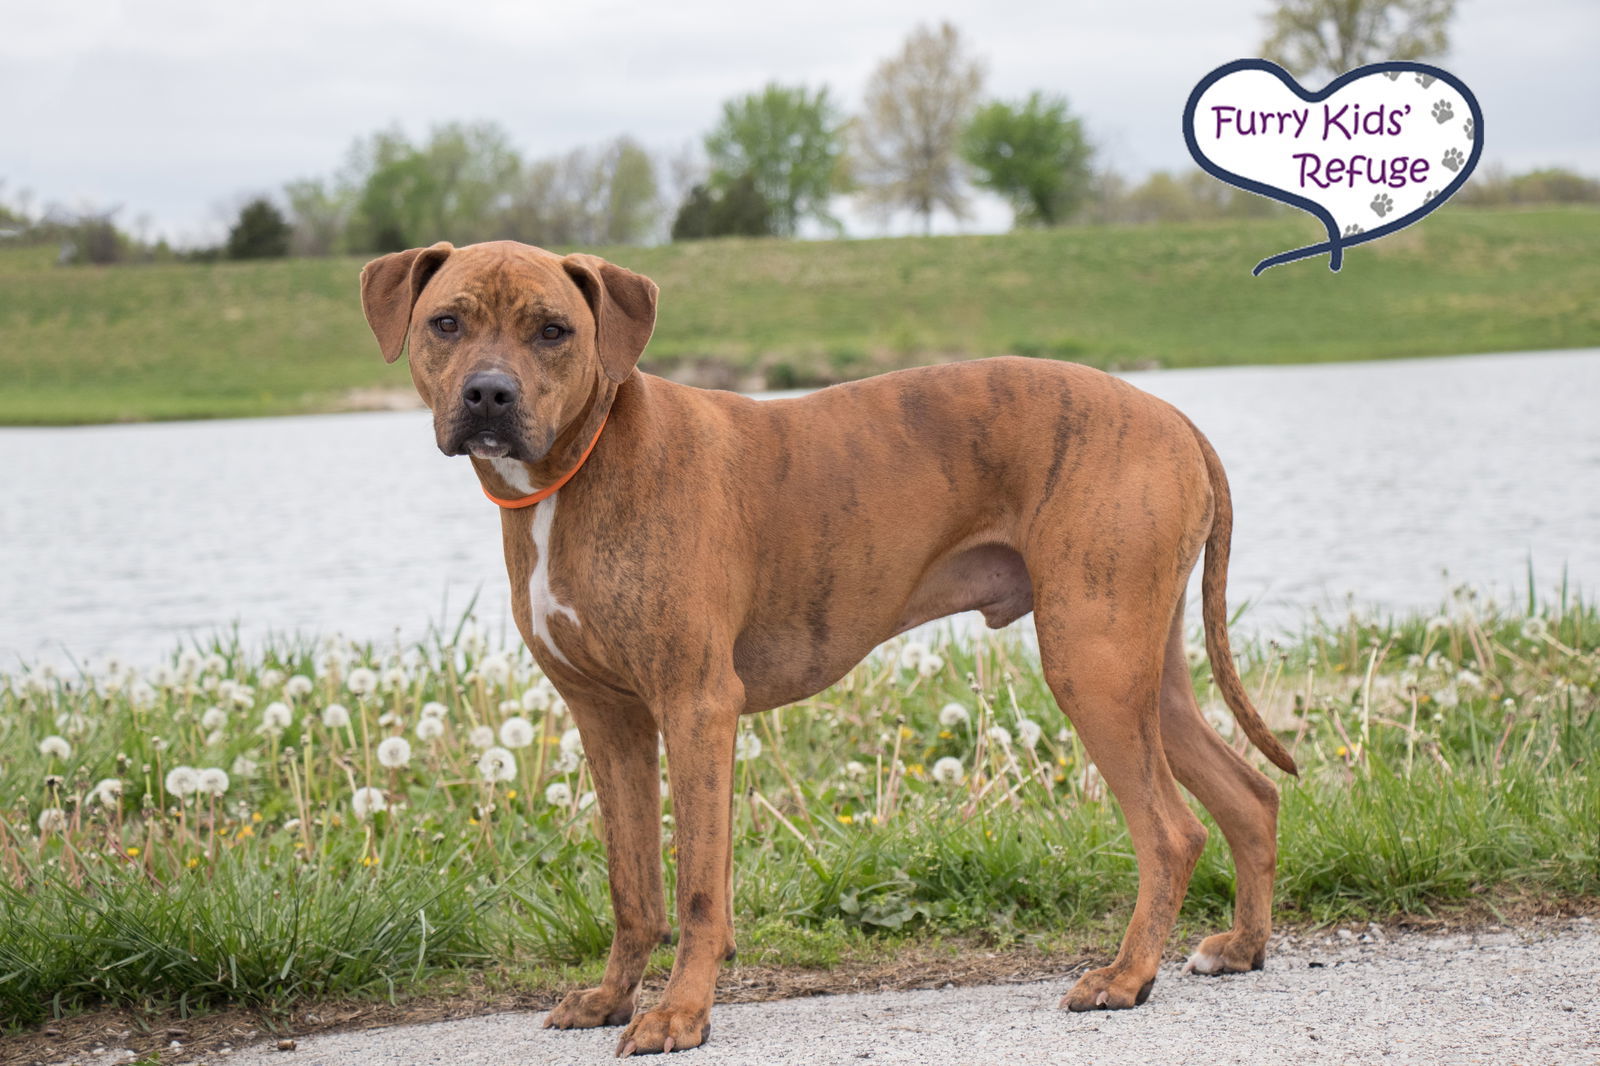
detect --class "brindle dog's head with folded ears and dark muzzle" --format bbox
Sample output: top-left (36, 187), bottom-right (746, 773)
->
top-left (362, 240), bottom-right (656, 463)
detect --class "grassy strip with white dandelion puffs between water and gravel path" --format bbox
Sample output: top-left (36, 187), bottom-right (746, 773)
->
top-left (0, 585), bottom-right (1600, 1028)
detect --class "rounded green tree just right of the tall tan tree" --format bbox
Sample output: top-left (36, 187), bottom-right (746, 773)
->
top-left (962, 93), bottom-right (1094, 226)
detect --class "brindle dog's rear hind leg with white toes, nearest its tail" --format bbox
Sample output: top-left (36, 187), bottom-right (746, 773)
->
top-left (1162, 602), bottom-right (1278, 973)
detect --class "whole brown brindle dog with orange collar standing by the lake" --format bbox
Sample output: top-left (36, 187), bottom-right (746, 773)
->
top-left (362, 242), bottom-right (1294, 1055)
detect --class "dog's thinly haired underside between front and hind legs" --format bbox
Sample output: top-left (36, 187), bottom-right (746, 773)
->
top-left (733, 544), bottom-right (1034, 714)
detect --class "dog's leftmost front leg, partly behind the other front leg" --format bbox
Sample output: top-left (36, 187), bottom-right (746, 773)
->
top-left (544, 699), bottom-right (672, 1029)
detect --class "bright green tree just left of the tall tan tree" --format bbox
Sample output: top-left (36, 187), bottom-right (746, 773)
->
top-left (706, 83), bottom-right (845, 237)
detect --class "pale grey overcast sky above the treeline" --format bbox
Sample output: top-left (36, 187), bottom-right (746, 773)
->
top-left (0, 0), bottom-right (1600, 243)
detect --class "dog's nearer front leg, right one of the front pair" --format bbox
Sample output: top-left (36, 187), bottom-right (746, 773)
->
top-left (618, 674), bottom-right (744, 1055)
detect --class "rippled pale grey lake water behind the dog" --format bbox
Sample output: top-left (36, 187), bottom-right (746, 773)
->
top-left (0, 349), bottom-right (1600, 671)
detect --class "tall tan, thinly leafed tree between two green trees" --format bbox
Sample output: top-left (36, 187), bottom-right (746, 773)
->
top-left (854, 22), bottom-right (984, 232)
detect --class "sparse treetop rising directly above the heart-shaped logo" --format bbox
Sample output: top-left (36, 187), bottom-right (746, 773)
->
top-left (1261, 0), bottom-right (1456, 80)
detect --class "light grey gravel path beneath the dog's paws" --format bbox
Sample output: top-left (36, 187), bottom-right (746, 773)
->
top-left (211, 919), bottom-right (1600, 1066)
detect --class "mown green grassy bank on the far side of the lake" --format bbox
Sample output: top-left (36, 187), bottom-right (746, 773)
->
top-left (0, 206), bottom-right (1600, 424)
